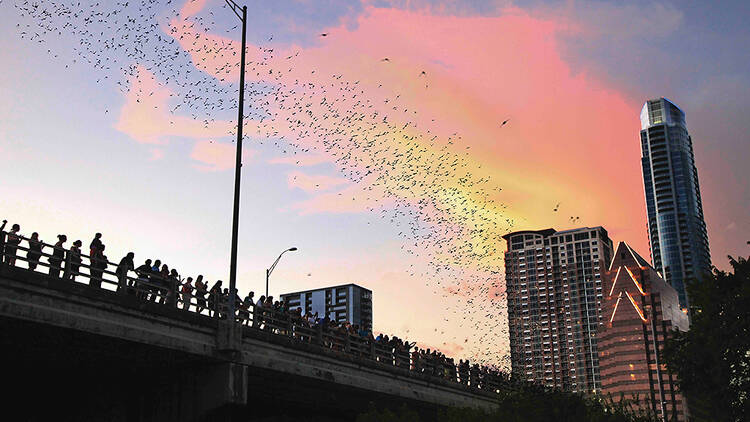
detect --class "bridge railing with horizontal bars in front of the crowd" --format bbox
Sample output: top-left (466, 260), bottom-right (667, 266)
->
top-left (0, 231), bottom-right (510, 392)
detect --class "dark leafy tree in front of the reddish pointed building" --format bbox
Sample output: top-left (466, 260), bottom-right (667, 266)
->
top-left (664, 256), bottom-right (750, 421)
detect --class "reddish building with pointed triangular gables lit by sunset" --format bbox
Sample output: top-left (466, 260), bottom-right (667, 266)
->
top-left (598, 242), bottom-right (689, 421)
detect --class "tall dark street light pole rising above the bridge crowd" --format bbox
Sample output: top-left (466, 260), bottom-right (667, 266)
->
top-left (224, 0), bottom-right (247, 321)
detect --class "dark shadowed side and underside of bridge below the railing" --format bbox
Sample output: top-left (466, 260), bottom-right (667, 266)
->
top-left (0, 269), bottom-right (506, 421)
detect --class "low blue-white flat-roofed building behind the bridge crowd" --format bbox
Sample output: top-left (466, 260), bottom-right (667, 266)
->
top-left (281, 284), bottom-right (372, 331)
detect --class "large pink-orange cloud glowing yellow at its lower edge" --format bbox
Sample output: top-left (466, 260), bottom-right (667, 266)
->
top-left (167, 7), bottom-right (647, 265)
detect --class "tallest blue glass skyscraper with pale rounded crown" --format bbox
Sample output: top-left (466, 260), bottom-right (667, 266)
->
top-left (641, 98), bottom-right (711, 308)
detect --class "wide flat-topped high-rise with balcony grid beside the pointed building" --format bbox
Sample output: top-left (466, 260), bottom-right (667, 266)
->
top-left (503, 227), bottom-right (612, 393)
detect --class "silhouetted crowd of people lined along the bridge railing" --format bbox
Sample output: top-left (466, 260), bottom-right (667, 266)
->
top-left (0, 220), bottom-right (508, 388)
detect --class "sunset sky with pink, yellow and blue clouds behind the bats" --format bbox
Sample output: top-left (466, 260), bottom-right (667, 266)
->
top-left (0, 0), bottom-right (750, 358)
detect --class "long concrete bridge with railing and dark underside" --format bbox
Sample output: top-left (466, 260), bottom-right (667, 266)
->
top-left (0, 232), bottom-right (508, 421)
